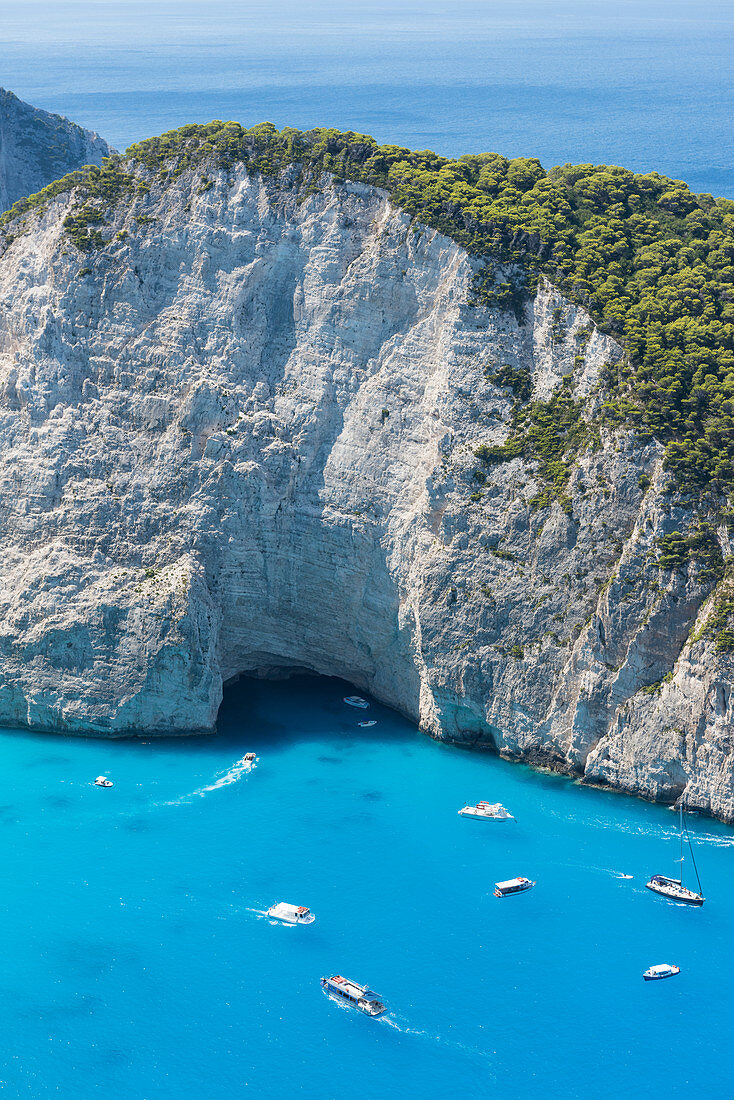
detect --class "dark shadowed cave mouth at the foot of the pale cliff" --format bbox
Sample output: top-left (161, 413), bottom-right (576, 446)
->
top-left (215, 669), bottom-right (419, 746)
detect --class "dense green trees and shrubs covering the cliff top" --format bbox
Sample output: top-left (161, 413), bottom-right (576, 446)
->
top-left (0, 122), bottom-right (734, 503)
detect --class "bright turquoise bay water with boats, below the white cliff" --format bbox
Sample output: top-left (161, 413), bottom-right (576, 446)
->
top-left (0, 679), bottom-right (734, 1100)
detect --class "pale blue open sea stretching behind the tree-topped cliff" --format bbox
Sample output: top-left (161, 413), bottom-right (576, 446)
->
top-left (0, 0), bottom-right (734, 198)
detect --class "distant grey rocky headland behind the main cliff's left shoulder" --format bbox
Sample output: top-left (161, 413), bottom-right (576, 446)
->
top-left (0, 88), bottom-right (112, 213)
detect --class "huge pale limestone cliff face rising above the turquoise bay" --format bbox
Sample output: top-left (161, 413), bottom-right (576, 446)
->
top-left (0, 160), bottom-right (734, 818)
